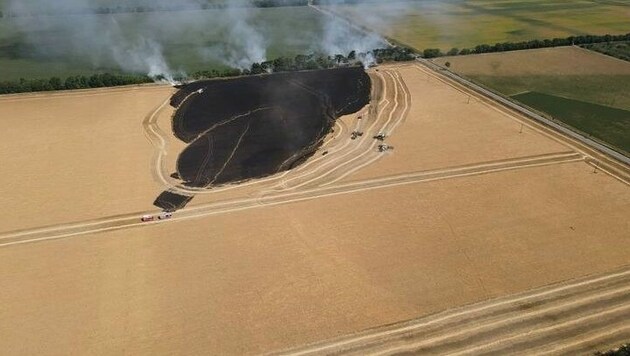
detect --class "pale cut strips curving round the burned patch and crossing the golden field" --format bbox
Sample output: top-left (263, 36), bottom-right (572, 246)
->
top-left (0, 63), bottom-right (630, 247)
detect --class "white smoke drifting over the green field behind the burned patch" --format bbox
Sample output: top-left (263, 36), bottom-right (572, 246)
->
top-left (0, 0), bottom-right (420, 80)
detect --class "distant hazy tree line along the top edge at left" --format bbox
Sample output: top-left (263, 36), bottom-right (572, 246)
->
top-left (0, 0), bottom-right (308, 18)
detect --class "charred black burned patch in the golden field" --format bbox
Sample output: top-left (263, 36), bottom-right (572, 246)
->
top-left (154, 67), bottom-right (371, 210)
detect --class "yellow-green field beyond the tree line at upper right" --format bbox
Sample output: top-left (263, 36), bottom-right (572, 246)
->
top-left (333, 0), bottom-right (630, 51)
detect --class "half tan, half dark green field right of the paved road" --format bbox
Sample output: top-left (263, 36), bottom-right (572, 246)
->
top-left (434, 47), bottom-right (630, 153)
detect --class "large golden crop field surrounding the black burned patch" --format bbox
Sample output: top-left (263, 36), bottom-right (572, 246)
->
top-left (0, 64), bottom-right (630, 355)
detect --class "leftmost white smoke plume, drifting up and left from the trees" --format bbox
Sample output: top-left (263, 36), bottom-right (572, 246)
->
top-left (2, 0), bottom-right (195, 82)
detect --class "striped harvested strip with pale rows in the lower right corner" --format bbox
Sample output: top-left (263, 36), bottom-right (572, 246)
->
top-left (280, 268), bottom-right (630, 356)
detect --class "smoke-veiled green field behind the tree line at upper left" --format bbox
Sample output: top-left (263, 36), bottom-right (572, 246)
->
top-left (0, 7), bottom-right (324, 81)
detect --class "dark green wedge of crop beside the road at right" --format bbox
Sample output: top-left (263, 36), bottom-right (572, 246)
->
top-left (512, 92), bottom-right (630, 154)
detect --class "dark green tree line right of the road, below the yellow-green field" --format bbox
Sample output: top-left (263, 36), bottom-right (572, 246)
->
top-left (422, 33), bottom-right (630, 58)
